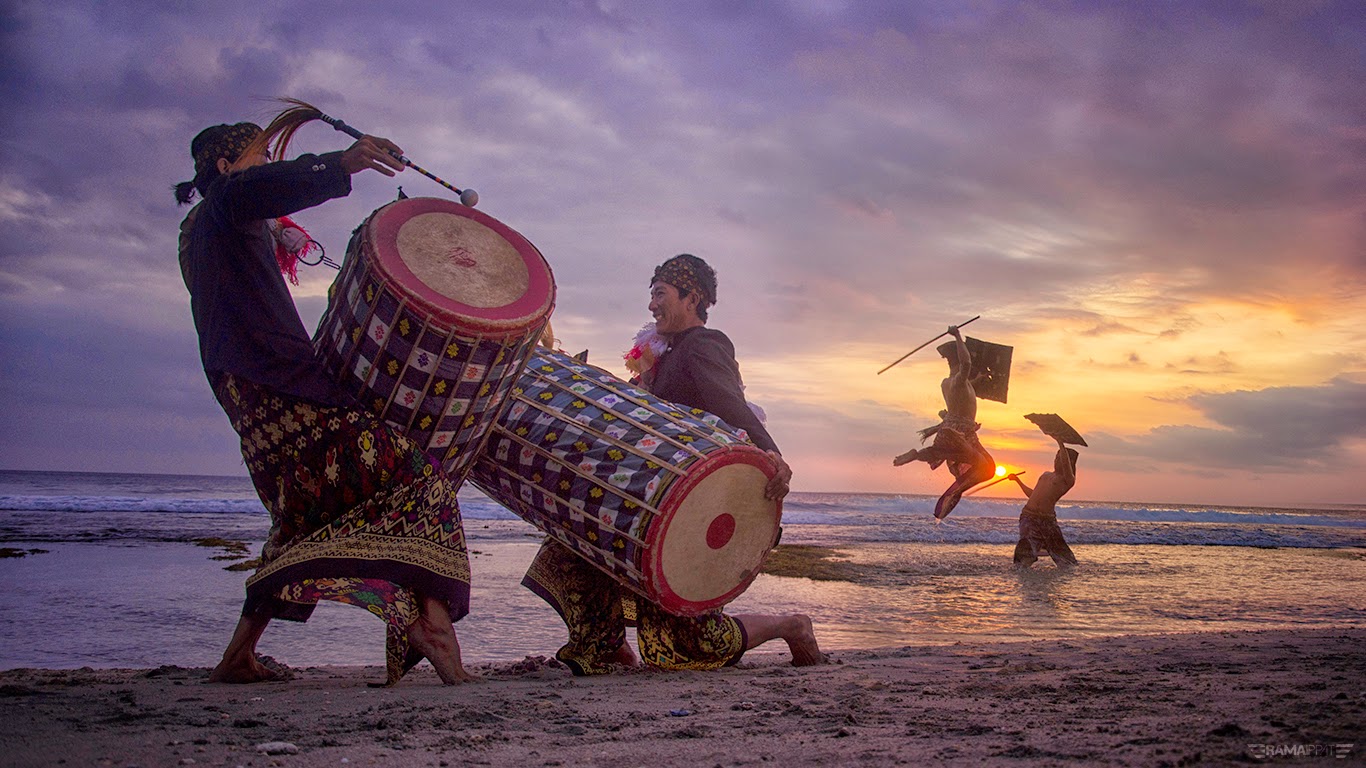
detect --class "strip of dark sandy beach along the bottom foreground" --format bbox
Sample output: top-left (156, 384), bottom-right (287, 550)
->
top-left (0, 629), bottom-right (1366, 768)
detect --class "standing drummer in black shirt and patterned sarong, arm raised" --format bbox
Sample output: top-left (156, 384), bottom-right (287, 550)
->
top-left (176, 115), bottom-right (471, 685)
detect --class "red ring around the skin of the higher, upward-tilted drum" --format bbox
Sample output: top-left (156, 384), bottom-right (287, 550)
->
top-left (367, 197), bottom-right (555, 335)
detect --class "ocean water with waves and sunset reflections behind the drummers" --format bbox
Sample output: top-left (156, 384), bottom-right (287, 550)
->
top-left (0, 471), bottom-right (1366, 668)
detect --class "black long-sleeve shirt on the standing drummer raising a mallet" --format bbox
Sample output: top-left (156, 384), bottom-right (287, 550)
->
top-left (180, 152), bottom-right (351, 404)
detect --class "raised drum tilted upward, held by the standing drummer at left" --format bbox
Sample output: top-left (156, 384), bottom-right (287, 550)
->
top-left (313, 198), bottom-right (555, 481)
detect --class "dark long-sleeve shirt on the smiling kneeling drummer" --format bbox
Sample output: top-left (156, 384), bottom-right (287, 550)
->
top-left (650, 325), bottom-right (777, 451)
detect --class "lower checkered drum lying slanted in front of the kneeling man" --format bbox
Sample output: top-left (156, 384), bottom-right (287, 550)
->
top-left (470, 348), bottom-right (783, 615)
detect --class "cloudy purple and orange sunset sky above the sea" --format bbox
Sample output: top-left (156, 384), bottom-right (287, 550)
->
top-left (0, 0), bottom-right (1366, 506)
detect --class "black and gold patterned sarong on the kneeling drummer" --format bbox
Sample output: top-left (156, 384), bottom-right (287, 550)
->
top-left (522, 540), bottom-right (747, 675)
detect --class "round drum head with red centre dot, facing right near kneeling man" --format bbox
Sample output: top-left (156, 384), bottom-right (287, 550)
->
top-left (643, 448), bottom-right (781, 615)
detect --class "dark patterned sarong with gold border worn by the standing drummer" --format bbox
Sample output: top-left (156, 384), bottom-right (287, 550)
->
top-left (213, 374), bottom-right (470, 685)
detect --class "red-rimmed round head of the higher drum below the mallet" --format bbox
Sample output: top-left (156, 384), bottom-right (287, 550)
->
top-left (365, 197), bottom-right (555, 335)
